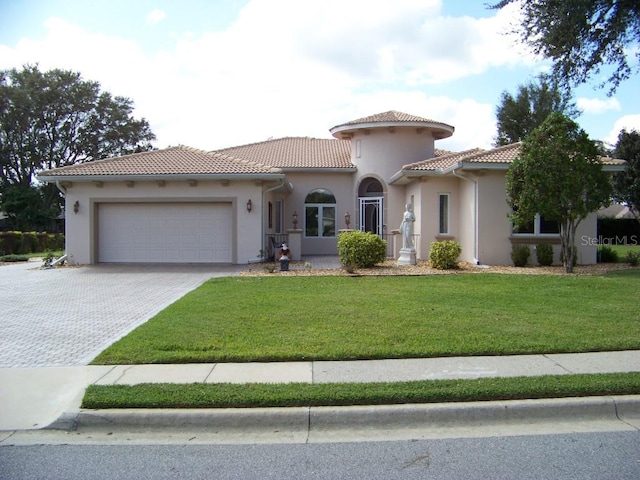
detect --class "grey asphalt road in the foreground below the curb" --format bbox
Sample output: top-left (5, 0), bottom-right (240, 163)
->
top-left (0, 432), bottom-right (640, 480)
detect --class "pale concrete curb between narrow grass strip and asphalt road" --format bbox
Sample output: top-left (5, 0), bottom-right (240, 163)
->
top-left (46, 395), bottom-right (640, 432)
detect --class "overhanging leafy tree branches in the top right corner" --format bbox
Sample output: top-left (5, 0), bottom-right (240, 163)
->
top-left (491, 0), bottom-right (640, 94)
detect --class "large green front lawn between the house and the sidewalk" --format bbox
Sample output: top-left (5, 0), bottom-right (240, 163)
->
top-left (93, 269), bottom-right (640, 364)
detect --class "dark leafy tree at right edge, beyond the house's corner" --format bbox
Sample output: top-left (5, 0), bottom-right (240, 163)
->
top-left (613, 130), bottom-right (640, 222)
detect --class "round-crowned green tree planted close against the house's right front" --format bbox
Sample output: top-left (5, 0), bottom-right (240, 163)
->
top-left (507, 113), bottom-right (611, 273)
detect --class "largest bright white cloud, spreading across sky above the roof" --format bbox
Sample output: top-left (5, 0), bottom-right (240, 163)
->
top-left (0, 0), bottom-right (535, 150)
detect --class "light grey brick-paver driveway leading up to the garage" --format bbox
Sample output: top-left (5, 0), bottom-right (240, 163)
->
top-left (0, 262), bottom-right (241, 368)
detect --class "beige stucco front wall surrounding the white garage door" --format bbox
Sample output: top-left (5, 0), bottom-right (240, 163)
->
top-left (66, 181), bottom-right (262, 264)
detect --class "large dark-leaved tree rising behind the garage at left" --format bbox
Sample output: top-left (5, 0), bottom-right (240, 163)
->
top-left (0, 65), bottom-right (155, 229)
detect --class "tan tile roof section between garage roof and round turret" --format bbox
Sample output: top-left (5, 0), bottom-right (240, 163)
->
top-left (216, 137), bottom-right (354, 169)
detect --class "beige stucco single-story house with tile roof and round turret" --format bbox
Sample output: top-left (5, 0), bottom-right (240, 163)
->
top-left (39, 111), bottom-right (624, 265)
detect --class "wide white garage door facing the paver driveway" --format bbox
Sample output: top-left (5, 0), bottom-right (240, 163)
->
top-left (98, 203), bottom-right (233, 263)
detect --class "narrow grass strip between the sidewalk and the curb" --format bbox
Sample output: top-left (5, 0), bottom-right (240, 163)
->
top-left (82, 373), bottom-right (640, 409)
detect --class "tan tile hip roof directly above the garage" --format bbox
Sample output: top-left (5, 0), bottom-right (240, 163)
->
top-left (38, 145), bottom-right (282, 177)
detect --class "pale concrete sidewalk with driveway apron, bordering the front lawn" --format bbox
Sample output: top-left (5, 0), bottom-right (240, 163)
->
top-left (0, 351), bottom-right (640, 431)
